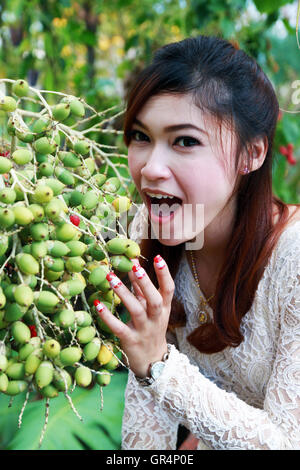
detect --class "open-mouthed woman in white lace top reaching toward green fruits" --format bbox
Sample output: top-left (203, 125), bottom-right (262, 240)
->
top-left (95, 35), bottom-right (300, 450)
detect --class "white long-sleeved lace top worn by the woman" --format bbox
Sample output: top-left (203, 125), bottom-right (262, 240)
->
top-left (122, 204), bottom-right (300, 450)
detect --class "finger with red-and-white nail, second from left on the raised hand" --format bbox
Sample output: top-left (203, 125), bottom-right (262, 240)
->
top-left (106, 272), bottom-right (147, 330)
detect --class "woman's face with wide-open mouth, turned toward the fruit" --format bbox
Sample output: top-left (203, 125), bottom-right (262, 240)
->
top-left (128, 94), bottom-right (239, 248)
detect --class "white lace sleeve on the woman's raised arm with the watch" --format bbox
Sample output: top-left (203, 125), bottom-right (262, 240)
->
top-left (142, 252), bottom-right (300, 450)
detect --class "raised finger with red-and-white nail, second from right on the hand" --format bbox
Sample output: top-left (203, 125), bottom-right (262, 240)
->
top-left (132, 265), bottom-right (163, 317)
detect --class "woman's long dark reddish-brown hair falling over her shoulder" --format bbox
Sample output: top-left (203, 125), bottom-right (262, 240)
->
top-left (124, 35), bottom-right (300, 353)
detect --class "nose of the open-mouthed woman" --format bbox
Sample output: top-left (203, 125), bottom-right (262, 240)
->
top-left (141, 147), bottom-right (171, 181)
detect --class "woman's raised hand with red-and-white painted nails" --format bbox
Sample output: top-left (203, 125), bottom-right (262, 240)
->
top-left (96, 255), bottom-right (175, 377)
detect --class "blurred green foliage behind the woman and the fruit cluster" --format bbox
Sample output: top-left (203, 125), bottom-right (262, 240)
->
top-left (0, 0), bottom-right (300, 450)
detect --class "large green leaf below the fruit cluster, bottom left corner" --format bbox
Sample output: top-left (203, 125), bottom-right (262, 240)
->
top-left (0, 371), bottom-right (127, 450)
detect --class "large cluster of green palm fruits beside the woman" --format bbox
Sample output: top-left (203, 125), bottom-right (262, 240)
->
top-left (0, 79), bottom-right (140, 434)
